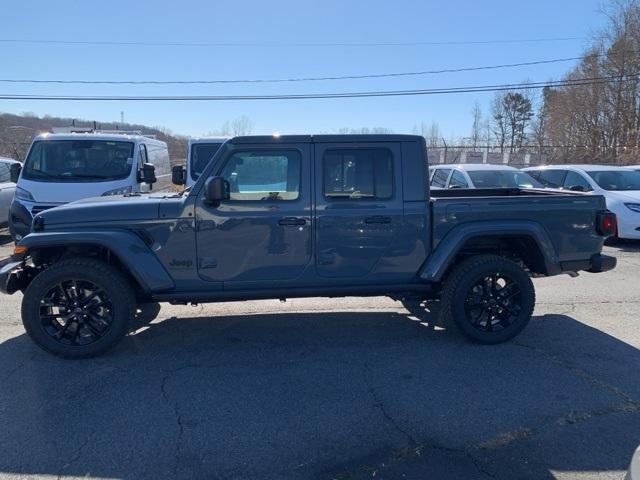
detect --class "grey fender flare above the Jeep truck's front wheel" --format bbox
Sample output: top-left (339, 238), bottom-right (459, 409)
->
top-left (19, 230), bottom-right (175, 293)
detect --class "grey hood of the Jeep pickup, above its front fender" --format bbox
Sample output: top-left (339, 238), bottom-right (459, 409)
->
top-left (37, 195), bottom-right (163, 228)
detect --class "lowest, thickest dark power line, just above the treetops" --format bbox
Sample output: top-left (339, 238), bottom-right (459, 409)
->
top-left (0, 73), bottom-right (640, 101)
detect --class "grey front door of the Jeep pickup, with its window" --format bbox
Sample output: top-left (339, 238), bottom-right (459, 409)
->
top-left (196, 143), bottom-right (312, 289)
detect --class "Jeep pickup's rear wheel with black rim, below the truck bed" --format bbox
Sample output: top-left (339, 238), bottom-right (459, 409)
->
top-left (441, 255), bottom-right (536, 344)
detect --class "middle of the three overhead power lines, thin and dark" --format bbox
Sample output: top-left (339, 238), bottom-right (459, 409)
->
top-left (0, 57), bottom-right (582, 85)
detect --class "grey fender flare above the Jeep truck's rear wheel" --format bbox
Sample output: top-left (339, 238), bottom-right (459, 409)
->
top-left (420, 220), bottom-right (561, 283)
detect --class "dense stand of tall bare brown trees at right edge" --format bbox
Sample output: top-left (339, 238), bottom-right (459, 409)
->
top-left (544, 0), bottom-right (640, 163)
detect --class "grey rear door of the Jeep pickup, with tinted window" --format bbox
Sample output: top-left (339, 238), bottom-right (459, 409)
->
top-left (314, 142), bottom-right (403, 280)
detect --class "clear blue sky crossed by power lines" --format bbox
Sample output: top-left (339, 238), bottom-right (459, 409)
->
top-left (0, 0), bottom-right (605, 138)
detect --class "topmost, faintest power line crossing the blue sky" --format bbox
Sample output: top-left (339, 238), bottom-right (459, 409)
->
top-left (0, 37), bottom-right (587, 48)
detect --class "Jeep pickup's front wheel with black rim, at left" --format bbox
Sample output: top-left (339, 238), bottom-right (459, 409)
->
top-left (22, 258), bottom-right (136, 358)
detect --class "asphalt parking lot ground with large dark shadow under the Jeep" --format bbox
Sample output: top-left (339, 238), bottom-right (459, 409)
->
top-left (0, 232), bottom-right (640, 480)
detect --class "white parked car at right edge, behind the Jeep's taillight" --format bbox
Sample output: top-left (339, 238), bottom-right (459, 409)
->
top-left (524, 165), bottom-right (640, 240)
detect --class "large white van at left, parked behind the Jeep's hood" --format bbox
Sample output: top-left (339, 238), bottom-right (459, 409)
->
top-left (9, 131), bottom-right (171, 241)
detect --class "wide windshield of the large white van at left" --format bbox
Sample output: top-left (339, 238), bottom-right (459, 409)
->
top-left (22, 140), bottom-right (133, 182)
